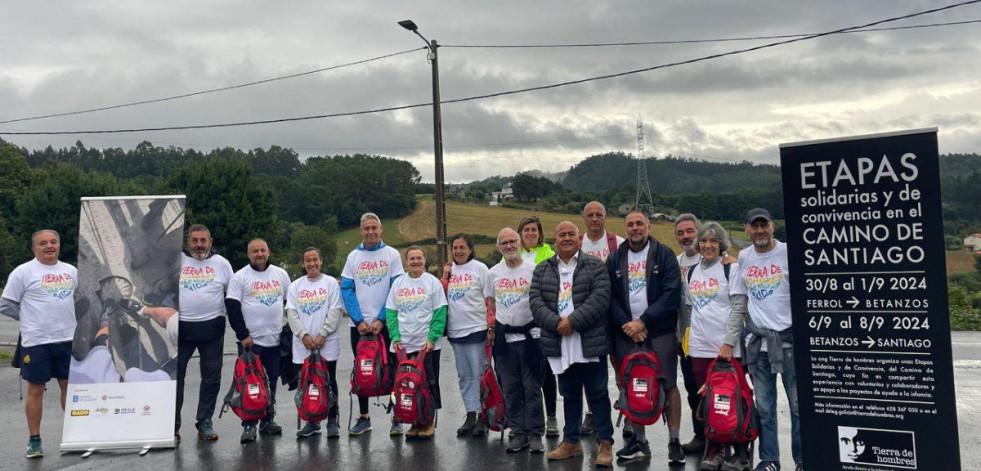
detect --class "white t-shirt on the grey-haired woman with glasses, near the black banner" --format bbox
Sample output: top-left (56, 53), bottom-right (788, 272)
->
top-left (685, 262), bottom-right (742, 358)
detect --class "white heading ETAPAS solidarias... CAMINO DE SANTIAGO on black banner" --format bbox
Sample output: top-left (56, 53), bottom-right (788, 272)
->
top-left (800, 153), bottom-right (925, 266)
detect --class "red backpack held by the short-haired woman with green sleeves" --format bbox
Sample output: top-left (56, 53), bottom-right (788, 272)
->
top-left (394, 349), bottom-right (436, 425)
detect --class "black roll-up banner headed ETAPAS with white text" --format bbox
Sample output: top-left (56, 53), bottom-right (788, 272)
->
top-left (780, 128), bottom-right (961, 471)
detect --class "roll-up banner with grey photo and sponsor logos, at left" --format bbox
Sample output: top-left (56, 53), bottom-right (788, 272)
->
top-left (61, 196), bottom-right (184, 451)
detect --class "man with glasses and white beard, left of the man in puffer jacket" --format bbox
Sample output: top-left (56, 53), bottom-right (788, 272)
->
top-left (484, 227), bottom-right (545, 453)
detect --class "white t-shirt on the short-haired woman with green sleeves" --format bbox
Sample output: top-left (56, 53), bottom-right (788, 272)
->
top-left (385, 273), bottom-right (446, 353)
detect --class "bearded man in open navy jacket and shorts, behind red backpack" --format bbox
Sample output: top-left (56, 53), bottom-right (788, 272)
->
top-left (606, 211), bottom-right (685, 463)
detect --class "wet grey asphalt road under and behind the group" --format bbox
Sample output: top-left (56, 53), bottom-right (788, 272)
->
top-left (0, 320), bottom-right (981, 471)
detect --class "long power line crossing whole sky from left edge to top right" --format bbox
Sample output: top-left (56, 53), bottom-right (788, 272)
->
top-left (0, 0), bottom-right (981, 136)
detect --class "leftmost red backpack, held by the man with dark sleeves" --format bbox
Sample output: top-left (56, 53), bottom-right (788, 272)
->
top-left (218, 348), bottom-right (269, 420)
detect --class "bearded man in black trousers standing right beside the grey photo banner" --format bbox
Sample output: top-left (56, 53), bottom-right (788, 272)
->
top-left (174, 224), bottom-right (232, 441)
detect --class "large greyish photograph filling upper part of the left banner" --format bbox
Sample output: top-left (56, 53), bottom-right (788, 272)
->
top-left (69, 197), bottom-right (184, 384)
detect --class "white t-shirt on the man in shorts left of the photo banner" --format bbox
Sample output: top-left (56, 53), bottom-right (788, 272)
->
top-left (3, 258), bottom-right (78, 347)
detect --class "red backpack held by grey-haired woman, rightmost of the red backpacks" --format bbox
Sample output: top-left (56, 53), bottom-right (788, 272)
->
top-left (697, 358), bottom-right (760, 444)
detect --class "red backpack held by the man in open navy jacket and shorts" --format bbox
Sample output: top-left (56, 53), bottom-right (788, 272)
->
top-left (617, 351), bottom-right (664, 425)
